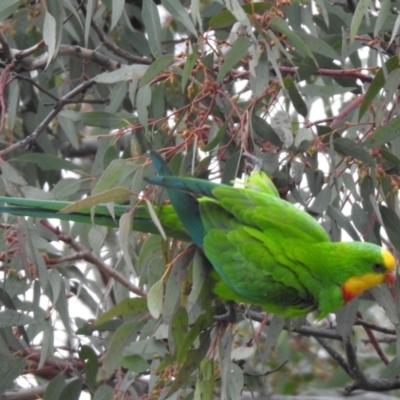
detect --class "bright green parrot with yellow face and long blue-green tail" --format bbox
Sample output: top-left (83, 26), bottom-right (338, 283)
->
top-left (0, 152), bottom-right (396, 319)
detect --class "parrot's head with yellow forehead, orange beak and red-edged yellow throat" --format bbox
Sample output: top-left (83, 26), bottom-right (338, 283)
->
top-left (342, 247), bottom-right (396, 303)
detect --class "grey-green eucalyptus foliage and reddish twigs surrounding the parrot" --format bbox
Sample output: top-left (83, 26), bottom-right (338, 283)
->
top-left (0, 0), bottom-right (400, 399)
